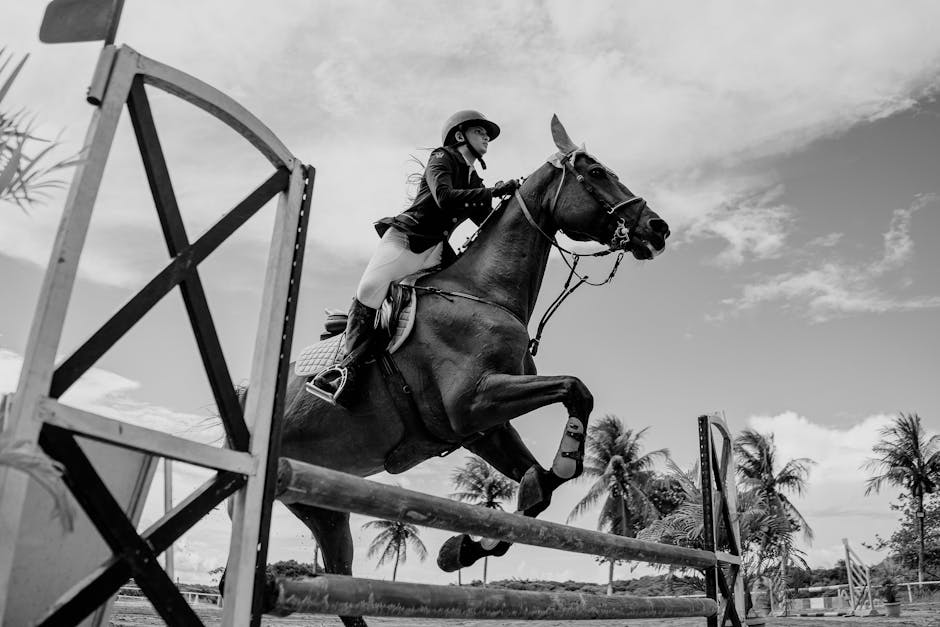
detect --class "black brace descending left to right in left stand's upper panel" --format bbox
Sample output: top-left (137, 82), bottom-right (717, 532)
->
top-left (127, 76), bottom-right (250, 451)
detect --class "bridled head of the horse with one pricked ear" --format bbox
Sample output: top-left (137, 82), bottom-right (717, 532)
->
top-left (536, 116), bottom-right (669, 259)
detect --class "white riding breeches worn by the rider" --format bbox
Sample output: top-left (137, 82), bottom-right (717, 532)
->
top-left (356, 227), bottom-right (444, 309)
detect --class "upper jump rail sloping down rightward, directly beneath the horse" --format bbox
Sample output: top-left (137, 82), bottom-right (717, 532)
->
top-left (276, 457), bottom-right (716, 568)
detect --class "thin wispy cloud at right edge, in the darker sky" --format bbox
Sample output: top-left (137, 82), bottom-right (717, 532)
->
top-left (715, 194), bottom-right (940, 322)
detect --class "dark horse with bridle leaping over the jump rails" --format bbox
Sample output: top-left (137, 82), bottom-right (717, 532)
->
top-left (234, 118), bottom-right (669, 626)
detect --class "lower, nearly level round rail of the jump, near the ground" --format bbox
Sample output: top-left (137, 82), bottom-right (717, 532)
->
top-left (275, 575), bottom-right (718, 620)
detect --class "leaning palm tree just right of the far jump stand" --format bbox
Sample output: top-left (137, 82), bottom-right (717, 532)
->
top-left (734, 429), bottom-right (816, 542)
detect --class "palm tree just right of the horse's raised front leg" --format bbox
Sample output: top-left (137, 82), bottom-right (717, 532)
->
top-left (568, 414), bottom-right (669, 595)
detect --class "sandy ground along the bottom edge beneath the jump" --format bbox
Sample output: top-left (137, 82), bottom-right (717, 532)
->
top-left (110, 601), bottom-right (940, 627)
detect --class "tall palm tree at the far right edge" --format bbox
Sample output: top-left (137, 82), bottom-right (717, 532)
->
top-left (864, 413), bottom-right (940, 581)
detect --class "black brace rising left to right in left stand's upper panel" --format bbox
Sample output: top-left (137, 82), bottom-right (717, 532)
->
top-left (49, 168), bottom-right (290, 398)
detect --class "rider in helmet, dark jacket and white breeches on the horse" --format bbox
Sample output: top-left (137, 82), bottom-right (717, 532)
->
top-left (308, 110), bottom-right (519, 404)
